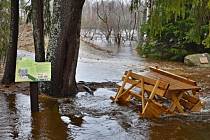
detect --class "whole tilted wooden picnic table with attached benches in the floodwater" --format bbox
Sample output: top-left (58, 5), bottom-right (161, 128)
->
top-left (112, 67), bottom-right (203, 118)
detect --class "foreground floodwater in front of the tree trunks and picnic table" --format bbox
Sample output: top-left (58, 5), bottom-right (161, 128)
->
top-left (0, 89), bottom-right (210, 140)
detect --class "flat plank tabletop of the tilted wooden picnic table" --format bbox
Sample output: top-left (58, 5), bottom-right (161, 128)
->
top-left (141, 71), bottom-right (200, 91)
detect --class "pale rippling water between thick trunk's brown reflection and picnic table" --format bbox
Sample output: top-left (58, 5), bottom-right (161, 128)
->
top-left (60, 89), bottom-right (148, 140)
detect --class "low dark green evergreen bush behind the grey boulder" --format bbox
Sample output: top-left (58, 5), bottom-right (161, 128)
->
top-left (138, 18), bottom-right (209, 61)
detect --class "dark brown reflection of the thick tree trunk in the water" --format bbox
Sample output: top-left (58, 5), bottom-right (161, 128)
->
top-left (31, 98), bottom-right (67, 140)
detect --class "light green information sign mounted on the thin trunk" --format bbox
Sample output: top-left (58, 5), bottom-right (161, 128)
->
top-left (15, 57), bottom-right (51, 82)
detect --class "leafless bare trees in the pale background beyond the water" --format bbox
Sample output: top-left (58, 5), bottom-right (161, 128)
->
top-left (82, 0), bottom-right (140, 45)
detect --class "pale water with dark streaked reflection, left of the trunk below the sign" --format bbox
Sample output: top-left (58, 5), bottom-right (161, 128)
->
top-left (0, 94), bottom-right (31, 139)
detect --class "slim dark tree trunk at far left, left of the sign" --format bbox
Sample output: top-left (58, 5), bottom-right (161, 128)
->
top-left (2, 0), bottom-right (19, 84)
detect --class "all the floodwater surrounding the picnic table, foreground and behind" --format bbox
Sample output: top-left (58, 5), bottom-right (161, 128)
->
top-left (0, 40), bottom-right (210, 140)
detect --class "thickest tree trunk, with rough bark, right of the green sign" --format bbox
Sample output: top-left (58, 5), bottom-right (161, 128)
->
top-left (48, 0), bottom-right (85, 96)
